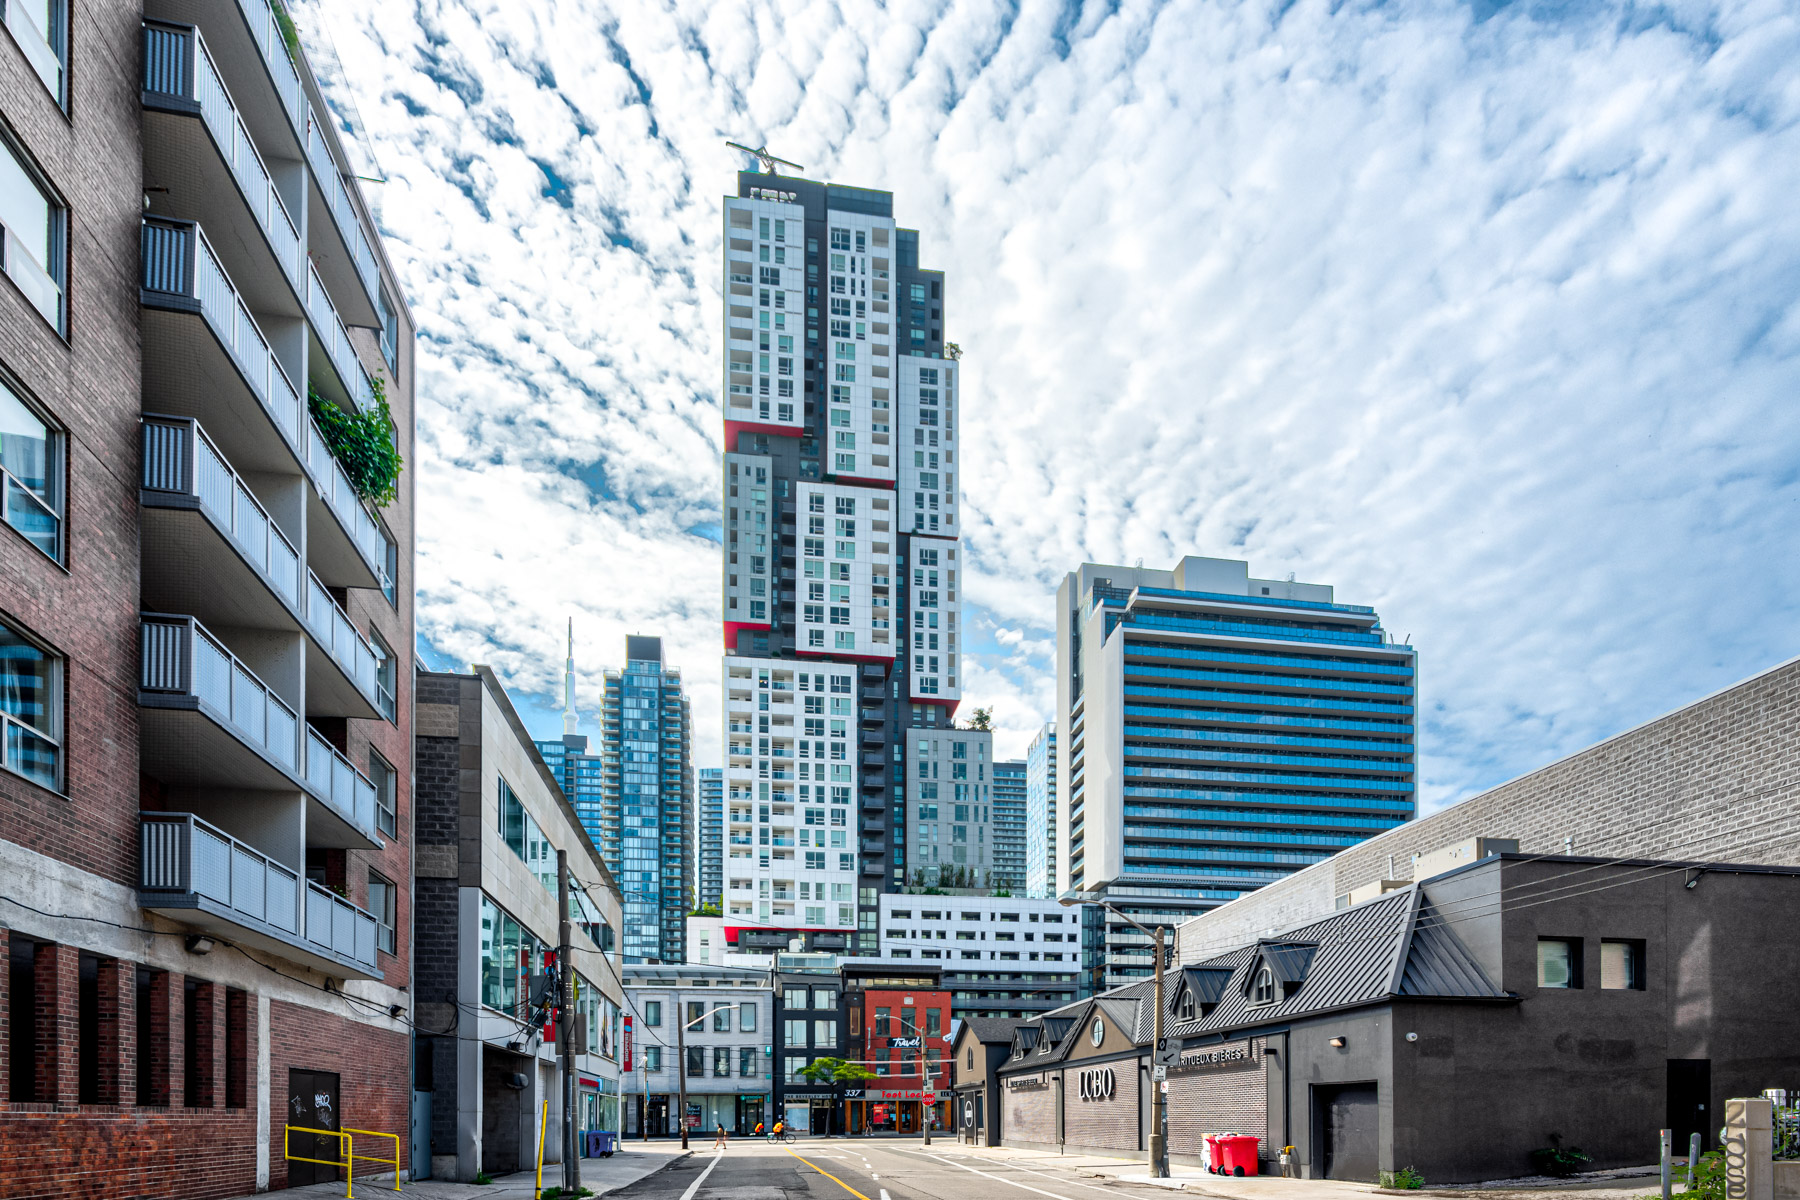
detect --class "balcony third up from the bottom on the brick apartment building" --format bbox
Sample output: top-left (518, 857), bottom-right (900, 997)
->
top-left (139, 414), bottom-right (380, 720)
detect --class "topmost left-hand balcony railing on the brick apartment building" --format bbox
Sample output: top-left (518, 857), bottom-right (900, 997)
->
top-left (144, 22), bottom-right (302, 291)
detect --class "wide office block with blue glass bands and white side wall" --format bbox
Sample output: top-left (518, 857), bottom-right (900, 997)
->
top-left (1057, 558), bottom-right (1417, 988)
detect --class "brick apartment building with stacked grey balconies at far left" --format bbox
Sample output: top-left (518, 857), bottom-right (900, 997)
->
top-left (0, 0), bottom-right (414, 1198)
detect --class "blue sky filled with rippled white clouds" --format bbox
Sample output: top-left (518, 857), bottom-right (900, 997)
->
top-left (301, 0), bottom-right (1800, 811)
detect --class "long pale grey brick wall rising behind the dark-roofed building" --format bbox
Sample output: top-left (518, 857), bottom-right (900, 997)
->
top-left (1179, 660), bottom-right (1800, 963)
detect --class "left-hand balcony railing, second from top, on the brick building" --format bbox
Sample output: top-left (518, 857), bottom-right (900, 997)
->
top-left (142, 218), bottom-right (301, 446)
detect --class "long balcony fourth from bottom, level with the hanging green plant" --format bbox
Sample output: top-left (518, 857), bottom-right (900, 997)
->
top-left (139, 218), bottom-right (387, 588)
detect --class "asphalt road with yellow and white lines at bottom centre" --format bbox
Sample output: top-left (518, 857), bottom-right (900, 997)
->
top-left (607, 1139), bottom-right (1166, 1200)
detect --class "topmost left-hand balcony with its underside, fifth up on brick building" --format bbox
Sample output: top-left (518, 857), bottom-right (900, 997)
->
top-left (142, 22), bottom-right (306, 317)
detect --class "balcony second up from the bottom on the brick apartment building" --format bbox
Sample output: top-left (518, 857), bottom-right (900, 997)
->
top-left (137, 613), bottom-right (382, 849)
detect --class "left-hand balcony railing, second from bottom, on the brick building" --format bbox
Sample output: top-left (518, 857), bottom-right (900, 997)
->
top-left (139, 613), bottom-right (301, 777)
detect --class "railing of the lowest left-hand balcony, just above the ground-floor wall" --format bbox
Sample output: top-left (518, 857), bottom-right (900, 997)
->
top-left (139, 813), bottom-right (301, 936)
